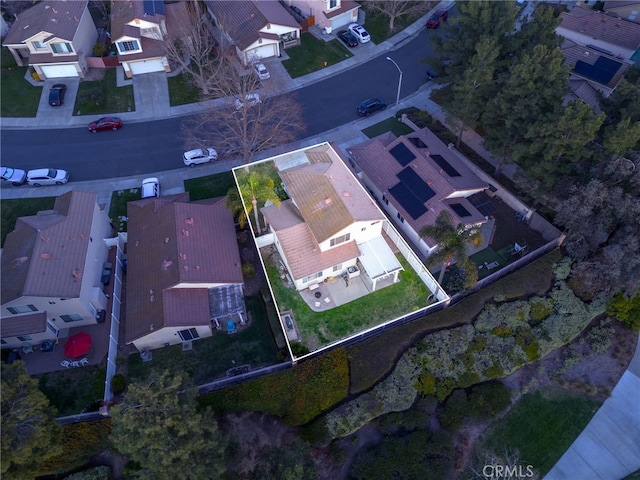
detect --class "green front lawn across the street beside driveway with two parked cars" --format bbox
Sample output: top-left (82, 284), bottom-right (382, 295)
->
top-left (282, 33), bottom-right (353, 78)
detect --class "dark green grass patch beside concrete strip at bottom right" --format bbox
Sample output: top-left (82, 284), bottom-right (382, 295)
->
top-left (479, 388), bottom-right (600, 477)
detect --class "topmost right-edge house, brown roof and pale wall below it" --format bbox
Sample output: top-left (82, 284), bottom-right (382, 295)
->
top-left (556, 7), bottom-right (640, 60)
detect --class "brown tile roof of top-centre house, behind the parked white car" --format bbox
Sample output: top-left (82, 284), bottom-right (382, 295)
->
top-left (205, 0), bottom-right (300, 50)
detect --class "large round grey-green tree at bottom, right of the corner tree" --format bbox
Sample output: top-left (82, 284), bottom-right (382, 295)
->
top-left (110, 371), bottom-right (226, 480)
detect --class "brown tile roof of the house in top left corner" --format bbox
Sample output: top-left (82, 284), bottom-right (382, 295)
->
top-left (3, 0), bottom-right (88, 45)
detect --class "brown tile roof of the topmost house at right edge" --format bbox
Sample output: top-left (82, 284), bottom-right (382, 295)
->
top-left (559, 7), bottom-right (640, 50)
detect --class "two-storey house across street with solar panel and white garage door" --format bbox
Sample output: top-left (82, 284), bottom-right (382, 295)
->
top-left (111, 0), bottom-right (186, 78)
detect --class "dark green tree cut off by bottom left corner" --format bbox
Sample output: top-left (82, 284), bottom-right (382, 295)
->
top-left (0, 361), bottom-right (62, 479)
